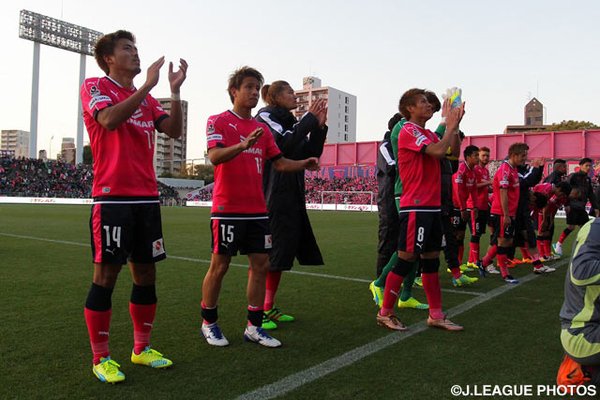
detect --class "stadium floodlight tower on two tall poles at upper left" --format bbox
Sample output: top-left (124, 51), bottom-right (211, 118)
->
top-left (19, 10), bottom-right (102, 164)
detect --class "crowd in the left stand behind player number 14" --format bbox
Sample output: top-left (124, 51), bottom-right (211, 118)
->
top-left (0, 156), bottom-right (179, 204)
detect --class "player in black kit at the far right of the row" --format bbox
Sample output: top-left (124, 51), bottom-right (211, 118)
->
top-left (553, 157), bottom-right (600, 256)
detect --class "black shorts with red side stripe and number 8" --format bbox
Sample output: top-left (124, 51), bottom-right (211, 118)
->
top-left (398, 211), bottom-right (443, 254)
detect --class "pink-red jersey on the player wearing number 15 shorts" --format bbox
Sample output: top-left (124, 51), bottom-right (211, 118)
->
top-left (206, 111), bottom-right (281, 215)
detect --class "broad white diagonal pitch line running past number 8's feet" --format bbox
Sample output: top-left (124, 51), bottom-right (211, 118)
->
top-left (237, 260), bottom-right (569, 400)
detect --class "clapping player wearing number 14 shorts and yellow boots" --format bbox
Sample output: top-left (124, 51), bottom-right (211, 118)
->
top-left (81, 30), bottom-right (188, 383)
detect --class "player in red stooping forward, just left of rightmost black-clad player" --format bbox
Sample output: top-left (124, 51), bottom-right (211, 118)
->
top-left (533, 181), bottom-right (571, 261)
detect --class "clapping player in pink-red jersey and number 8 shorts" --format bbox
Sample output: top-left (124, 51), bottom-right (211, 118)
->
top-left (377, 89), bottom-right (464, 331)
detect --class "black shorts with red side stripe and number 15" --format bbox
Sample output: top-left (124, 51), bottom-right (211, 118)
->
top-left (210, 216), bottom-right (273, 256)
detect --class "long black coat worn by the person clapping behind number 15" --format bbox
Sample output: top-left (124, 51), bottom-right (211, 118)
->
top-left (256, 106), bottom-right (327, 271)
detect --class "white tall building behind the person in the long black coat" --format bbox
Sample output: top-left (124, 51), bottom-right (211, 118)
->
top-left (294, 76), bottom-right (356, 143)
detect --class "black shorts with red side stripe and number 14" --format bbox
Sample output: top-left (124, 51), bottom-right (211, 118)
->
top-left (90, 200), bottom-right (167, 265)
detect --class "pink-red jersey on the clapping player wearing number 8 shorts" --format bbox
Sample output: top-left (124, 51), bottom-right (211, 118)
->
top-left (398, 122), bottom-right (442, 212)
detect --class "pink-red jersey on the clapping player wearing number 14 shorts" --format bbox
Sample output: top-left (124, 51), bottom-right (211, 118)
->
top-left (81, 76), bottom-right (169, 197)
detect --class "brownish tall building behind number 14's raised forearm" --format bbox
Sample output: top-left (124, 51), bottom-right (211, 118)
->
top-left (154, 98), bottom-right (188, 176)
